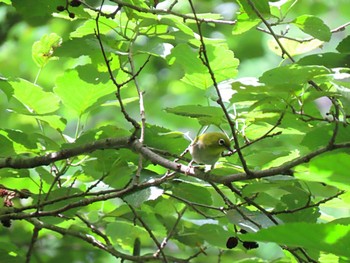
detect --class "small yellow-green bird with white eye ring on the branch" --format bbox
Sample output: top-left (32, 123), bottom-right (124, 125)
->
top-left (190, 132), bottom-right (232, 165)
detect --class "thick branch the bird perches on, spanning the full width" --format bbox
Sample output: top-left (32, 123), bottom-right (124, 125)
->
top-left (0, 138), bottom-right (350, 184)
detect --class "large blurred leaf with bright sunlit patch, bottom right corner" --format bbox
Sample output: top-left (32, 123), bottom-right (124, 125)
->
top-left (240, 223), bottom-right (350, 257)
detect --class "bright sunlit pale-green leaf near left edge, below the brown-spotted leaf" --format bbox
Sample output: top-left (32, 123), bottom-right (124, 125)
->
top-left (8, 79), bottom-right (59, 114)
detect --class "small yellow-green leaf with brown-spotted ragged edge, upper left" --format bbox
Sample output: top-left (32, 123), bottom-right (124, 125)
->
top-left (32, 33), bottom-right (62, 68)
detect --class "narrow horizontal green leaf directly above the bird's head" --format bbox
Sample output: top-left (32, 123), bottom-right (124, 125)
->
top-left (165, 105), bottom-right (225, 126)
